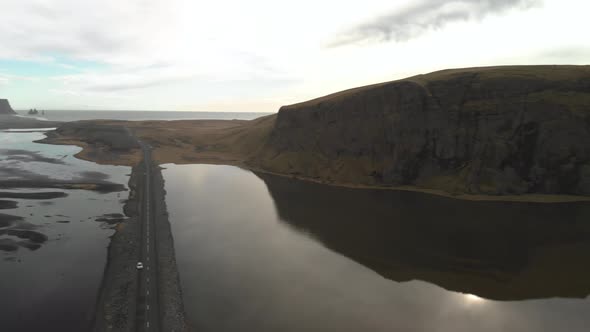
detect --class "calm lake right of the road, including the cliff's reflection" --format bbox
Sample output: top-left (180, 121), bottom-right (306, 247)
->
top-left (164, 165), bottom-right (590, 331)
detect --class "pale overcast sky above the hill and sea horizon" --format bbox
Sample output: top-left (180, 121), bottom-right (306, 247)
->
top-left (0, 0), bottom-right (590, 112)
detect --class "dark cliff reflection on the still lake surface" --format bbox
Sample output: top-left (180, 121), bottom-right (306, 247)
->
top-left (257, 173), bottom-right (590, 300)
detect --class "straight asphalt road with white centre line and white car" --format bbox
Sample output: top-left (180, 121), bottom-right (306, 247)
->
top-left (136, 141), bottom-right (160, 331)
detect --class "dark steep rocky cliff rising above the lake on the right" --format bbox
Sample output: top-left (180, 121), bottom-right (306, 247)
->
top-left (253, 66), bottom-right (590, 195)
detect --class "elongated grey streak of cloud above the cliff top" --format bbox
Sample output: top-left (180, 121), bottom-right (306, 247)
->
top-left (328, 0), bottom-right (542, 47)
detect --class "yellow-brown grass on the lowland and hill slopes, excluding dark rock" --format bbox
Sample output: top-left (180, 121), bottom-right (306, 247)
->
top-left (40, 66), bottom-right (590, 201)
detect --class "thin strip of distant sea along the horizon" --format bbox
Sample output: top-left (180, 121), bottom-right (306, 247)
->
top-left (13, 111), bottom-right (270, 121)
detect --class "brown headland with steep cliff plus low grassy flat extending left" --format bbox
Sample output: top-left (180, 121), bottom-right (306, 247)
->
top-left (45, 66), bottom-right (590, 201)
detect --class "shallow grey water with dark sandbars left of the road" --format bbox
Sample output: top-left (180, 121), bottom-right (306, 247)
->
top-left (0, 131), bottom-right (130, 331)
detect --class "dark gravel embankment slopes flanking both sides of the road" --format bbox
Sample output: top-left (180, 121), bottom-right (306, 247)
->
top-left (94, 137), bottom-right (187, 332)
